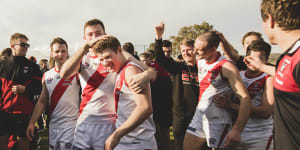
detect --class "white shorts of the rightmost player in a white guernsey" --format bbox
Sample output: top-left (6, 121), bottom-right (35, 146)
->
top-left (233, 136), bottom-right (273, 150)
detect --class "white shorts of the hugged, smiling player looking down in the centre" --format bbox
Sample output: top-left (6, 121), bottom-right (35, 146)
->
top-left (114, 136), bottom-right (157, 150)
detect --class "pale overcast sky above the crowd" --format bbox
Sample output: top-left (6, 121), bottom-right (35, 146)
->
top-left (0, 0), bottom-right (280, 60)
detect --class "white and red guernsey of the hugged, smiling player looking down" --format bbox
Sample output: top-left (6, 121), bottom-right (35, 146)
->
top-left (114, 61), bottom-right (155, 143)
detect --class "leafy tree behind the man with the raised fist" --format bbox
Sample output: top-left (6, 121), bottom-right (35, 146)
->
top-left (169, 21), bottom-right (213, 57)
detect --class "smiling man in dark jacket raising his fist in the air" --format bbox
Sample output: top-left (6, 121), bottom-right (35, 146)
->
top-left (154, 23), bottom-right (199, 150)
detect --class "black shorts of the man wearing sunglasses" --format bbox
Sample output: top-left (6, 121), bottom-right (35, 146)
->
top-left (0, 111), bottom-right (30, 138)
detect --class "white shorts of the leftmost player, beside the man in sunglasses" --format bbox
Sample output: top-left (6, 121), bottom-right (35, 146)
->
top-left (49, 127), bottom-right (74, 150)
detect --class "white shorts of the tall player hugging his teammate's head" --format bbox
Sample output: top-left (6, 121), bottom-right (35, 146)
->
top-left (73, 122), bottom-right (115, 150)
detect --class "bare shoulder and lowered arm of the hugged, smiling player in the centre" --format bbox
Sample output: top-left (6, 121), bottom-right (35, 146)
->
top-left (105, 66), bottom-right (152, 150)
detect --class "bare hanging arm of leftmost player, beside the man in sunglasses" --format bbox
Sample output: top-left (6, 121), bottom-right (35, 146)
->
top-left (26, 82), bottom-right (49, 141)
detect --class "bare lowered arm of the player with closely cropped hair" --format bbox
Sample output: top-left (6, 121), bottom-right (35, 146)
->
top-left (222, 62), bottom-right (251, 146)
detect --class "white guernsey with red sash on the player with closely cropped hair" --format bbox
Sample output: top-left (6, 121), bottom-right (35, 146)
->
top-left (197, 53), bottom-right (232, 124)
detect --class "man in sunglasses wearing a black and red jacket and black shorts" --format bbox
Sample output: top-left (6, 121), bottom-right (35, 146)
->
top-left (0, 33), bottom-right (41, 150)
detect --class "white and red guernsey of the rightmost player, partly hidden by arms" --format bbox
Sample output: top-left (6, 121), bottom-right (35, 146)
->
top-left (240, 71), bottom-right (273, 138)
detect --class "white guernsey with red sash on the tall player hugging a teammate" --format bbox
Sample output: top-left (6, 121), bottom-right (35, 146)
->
top-left (77, 54), bottom-right (116, 124)
